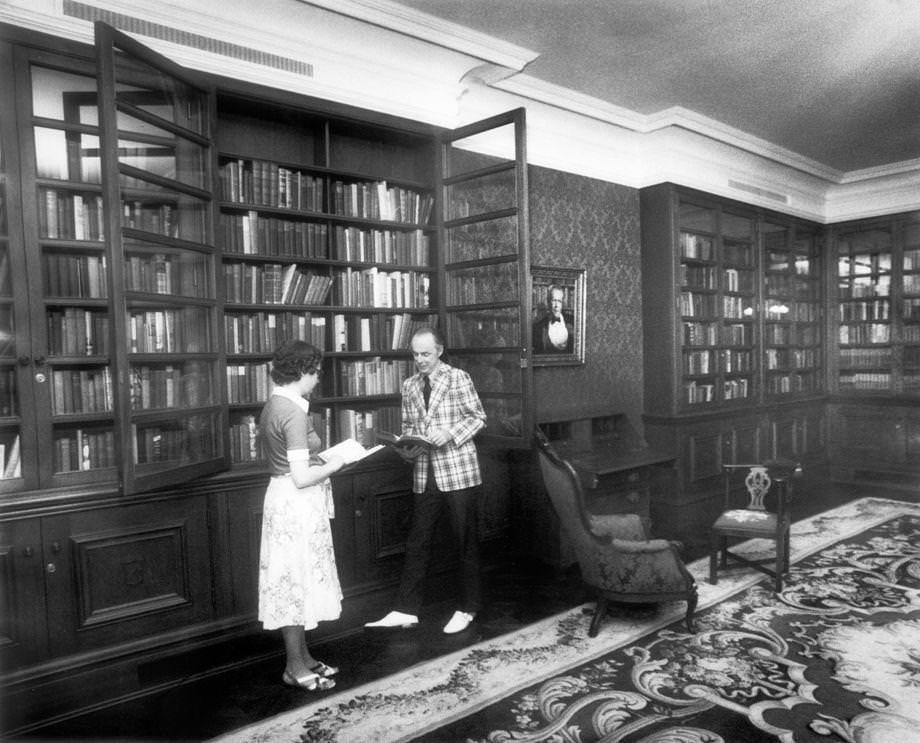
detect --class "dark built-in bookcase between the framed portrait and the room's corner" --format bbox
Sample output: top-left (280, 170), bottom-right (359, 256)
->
top-left (640, 183), bottom-right (826, 539)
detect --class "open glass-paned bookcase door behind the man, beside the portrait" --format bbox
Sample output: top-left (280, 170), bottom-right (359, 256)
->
top-left (439, 108), bottom-right (533, 448)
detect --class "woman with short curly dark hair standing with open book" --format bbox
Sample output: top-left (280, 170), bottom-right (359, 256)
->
top-left (259, 340), bottom-right (344, 691)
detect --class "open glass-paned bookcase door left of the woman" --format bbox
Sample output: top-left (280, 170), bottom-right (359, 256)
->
top-left (96, 23), bottom-right (229, 493)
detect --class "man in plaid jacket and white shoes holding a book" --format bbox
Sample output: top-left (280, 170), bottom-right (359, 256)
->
top-left (365, 326), bottom-right (486, 634)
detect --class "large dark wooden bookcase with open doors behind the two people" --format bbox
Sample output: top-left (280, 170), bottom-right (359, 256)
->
top-left (0, 24), bottom-right (532, 727)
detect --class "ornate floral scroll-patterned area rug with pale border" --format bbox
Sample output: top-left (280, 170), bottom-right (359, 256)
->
top-left (220, 498), bottom-right (920, 743)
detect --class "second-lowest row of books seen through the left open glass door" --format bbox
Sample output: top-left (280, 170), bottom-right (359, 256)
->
top-left (131, 362), bottom-right (215, 410)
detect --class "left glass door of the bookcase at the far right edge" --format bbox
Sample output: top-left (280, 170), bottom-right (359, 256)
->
top-left (837, 225), bottom-right (894, 393)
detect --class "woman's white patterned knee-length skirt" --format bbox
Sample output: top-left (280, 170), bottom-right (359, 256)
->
top-left (259, 477), bottom-right (342, 630)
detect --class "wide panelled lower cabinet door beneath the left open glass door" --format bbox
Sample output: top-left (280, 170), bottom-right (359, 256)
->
top-left (42, 496), bottom-right (212, 655)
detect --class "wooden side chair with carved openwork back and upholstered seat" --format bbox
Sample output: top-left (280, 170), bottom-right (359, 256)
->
top-left (709, 460), bottom-right (802, 593)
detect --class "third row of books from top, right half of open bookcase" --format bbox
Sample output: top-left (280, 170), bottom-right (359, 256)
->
top-left (332, 266), bottom-right (431, 309)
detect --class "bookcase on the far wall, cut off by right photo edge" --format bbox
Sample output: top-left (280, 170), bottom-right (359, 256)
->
top-left (830, 213), bottom-right (920, 487)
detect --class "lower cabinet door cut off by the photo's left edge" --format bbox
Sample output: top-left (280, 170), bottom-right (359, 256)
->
top-left (0, 519), bottom-right (47, 670)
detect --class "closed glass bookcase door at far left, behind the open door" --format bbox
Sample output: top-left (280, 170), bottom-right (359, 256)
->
top-left (16, 50), bottom-right (116, 487)
